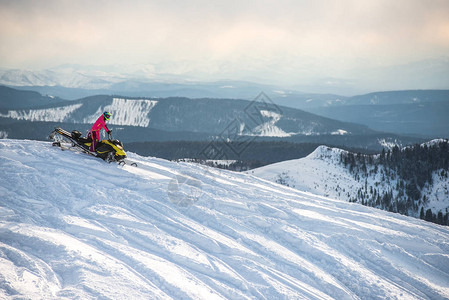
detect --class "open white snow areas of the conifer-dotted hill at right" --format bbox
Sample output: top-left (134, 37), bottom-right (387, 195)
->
top-left (248, 144), bottom-right (449, 217)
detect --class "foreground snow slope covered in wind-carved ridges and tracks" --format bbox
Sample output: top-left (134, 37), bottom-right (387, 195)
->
top-left (0, 140), bottom-right (449, 299)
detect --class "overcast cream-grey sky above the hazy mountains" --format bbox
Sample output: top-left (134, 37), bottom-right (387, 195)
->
top-left (0, 0), bottom-right (449, 90)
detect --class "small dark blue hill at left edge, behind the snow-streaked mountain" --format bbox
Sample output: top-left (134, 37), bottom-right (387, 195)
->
top-left (0, 85), bottom-right (64, 109)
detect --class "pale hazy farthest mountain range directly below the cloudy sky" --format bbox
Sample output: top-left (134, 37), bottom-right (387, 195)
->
top-left (0, 55), bottom-right (449, 94)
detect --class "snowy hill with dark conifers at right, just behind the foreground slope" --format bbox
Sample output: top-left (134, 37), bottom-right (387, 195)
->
top-left (249, 140), bottom-right (449, 225)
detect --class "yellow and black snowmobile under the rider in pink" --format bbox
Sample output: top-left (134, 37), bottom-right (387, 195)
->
top-left (49, 127), bottom-right (137, 166)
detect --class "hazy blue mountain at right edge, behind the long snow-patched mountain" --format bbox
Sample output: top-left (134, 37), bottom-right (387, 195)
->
top-left (274, 90), bottom-right (449, 138)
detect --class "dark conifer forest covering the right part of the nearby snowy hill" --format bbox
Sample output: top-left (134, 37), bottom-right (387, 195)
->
top-left (340, 140), bottom-right (449, 225)
